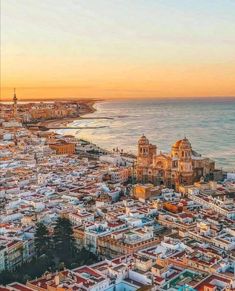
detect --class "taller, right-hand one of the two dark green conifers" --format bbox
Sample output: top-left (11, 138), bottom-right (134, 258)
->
top-left (53, 217), bottom-right (77, 264)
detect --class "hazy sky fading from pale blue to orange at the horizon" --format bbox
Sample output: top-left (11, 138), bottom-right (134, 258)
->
top-left (1, 0), bottom-right (235, 98)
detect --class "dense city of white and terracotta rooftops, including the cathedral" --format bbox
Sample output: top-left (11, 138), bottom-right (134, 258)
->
top-left (0, 93), bottom-right (235, 291)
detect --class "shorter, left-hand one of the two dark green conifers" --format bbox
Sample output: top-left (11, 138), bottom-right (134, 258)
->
top-left (34, 222), bottom-right (51, 257)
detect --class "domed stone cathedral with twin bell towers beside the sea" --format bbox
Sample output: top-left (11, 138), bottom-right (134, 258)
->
top-left (135, 135), bottom-right (215, 189)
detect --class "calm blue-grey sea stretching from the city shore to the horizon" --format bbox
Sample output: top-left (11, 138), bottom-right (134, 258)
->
top-left (57, 98), bottom-right (235, 170)
